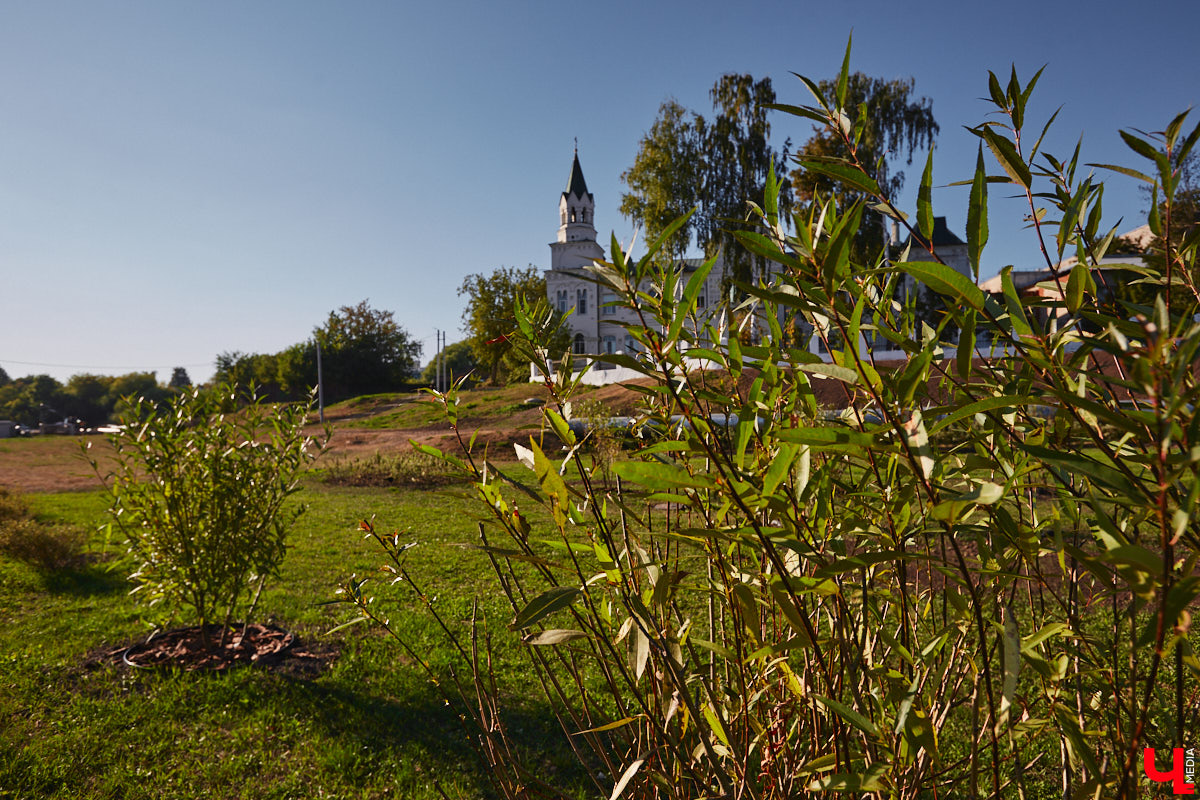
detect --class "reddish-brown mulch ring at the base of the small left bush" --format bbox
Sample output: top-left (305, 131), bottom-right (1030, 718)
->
top-left (84, 624), bottom-right (338, 679)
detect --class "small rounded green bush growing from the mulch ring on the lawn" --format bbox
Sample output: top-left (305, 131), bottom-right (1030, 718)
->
top-left (84, 385), bottom-right (318, 638)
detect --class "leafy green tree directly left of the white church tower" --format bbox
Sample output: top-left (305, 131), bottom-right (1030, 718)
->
top-left (458, 266), bottom-right (569, 384)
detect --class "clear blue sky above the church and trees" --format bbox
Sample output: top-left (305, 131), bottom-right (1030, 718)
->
top-left (0, 0), bottom-right (1200, 380)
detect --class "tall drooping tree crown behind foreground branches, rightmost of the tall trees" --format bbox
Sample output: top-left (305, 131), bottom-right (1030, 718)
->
top-left (791, 72), bottom-right (938, 263)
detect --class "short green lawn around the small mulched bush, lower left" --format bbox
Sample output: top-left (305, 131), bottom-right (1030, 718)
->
top-left (0, 481), bottom-right (584, 798)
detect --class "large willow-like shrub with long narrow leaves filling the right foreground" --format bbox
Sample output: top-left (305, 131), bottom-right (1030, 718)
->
top-left (348, 45), bottom-right (1200, 799)
